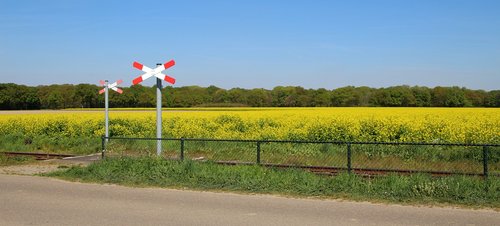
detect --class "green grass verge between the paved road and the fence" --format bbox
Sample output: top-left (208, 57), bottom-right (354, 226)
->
top-left (46, 157), bottom-right (500, 208)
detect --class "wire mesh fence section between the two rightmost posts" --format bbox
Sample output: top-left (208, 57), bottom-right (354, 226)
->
top-left (352, 144), bottom-right (483, 175)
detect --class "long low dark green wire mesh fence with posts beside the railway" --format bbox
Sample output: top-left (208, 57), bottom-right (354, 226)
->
top-left (102, 137), bottom-right (500, 177)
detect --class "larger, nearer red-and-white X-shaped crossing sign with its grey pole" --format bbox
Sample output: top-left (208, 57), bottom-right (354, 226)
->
top-left (132, 60), bottom-right (175, 155)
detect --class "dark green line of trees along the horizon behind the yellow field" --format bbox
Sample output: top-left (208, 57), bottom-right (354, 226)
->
top-left (0, 83), bottom-right (500, 110)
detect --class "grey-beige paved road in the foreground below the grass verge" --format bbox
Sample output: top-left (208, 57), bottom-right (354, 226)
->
top-left (0, 174), bottom-right (500, 226)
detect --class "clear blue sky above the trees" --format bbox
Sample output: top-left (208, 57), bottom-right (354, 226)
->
top-left (0, 0), bottom-right (500, 90)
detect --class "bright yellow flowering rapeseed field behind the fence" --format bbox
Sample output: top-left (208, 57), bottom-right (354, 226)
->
top-left (0, 108), bottom-right (500, 143)
